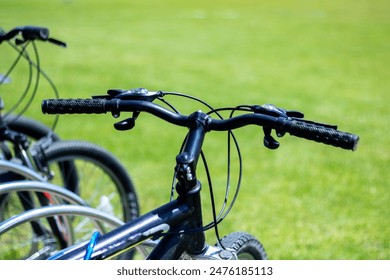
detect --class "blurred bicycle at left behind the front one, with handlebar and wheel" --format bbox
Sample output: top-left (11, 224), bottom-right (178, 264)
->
top-left (0, 26), bottom-right (138, 221)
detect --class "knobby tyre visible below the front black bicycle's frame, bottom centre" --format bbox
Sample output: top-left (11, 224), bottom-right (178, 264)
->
top-left (217, 232), bottom-right (267, 260)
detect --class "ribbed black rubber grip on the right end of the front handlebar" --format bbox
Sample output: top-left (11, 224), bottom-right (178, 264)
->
top-left (284, 120), bottom-right (359, 151)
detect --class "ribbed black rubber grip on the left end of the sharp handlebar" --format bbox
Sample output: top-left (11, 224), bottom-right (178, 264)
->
top-left (42, 99), bottom-right (107, 114)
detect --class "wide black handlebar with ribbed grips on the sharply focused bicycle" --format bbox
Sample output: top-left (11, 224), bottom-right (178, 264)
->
top-left (42, 98), bottom-right (359, 151)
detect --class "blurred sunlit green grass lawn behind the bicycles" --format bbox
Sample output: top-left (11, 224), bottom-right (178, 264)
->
top-left (0, 0), bottom-right (390, 259)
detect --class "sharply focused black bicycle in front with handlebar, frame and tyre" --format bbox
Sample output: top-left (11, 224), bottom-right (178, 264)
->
top-left (42, 89), bottom-right (359, 260)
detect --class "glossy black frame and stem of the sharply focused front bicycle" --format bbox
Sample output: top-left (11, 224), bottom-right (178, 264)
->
top-left (50, 112), bottom-right (213, 259)
